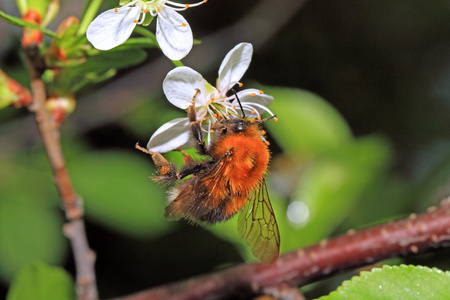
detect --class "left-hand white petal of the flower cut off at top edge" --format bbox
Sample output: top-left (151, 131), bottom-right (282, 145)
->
top-left (86, 6), bottom-right (141, 50)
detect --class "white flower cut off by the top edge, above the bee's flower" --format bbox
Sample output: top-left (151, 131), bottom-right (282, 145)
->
top-left (86, 0), bottom-right (207, 60)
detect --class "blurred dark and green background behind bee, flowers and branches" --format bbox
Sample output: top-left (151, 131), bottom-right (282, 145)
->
top-left (0, 0), bottom-right (450, 298)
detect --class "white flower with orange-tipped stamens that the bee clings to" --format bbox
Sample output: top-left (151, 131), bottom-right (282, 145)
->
top-left (147, 43), bottom-right (273, 153)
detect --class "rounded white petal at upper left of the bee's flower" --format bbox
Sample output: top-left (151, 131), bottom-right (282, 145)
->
top-left (163, 66), bottom-right (206, 109)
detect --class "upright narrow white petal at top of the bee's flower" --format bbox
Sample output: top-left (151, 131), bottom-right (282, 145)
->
top-left (217, 43), bottom-right (253, 95)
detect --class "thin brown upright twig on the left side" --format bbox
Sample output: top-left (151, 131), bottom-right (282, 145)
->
top-left (25, 48), bottom-right (98, 300)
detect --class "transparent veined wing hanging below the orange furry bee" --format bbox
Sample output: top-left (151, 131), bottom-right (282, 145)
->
top-left (238, 179), bottom-right (280, 264)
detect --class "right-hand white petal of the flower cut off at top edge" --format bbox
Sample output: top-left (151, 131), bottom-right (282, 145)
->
top-left (156, 7), bottom-right (194, 60)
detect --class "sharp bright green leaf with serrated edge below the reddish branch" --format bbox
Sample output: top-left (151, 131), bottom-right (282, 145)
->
top-left (319, 265), bottom-right (450, 300)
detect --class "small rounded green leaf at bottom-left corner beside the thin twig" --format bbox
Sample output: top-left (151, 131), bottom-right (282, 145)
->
top-left (7, 261), bottom-right (75, 300)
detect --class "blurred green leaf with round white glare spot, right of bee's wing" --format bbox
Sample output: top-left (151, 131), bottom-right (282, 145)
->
top-left (280, 137), bottom-right (390, 251)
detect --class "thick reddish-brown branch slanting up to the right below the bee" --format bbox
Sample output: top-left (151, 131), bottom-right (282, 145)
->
top-left (116, 198), bottom-right (450, 300)
